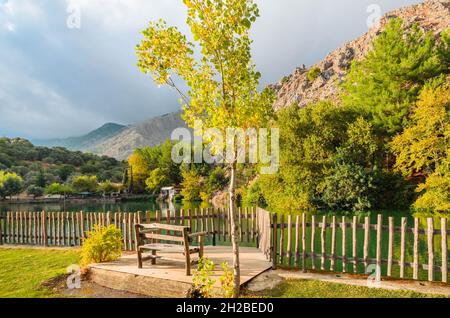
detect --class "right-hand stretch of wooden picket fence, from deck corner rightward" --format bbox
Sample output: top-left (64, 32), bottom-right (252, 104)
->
top-left (271, 214), bottom-right (450, 283)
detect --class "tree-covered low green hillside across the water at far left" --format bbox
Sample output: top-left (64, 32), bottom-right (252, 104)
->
top-left (0, 138), bottom-right (126, 199)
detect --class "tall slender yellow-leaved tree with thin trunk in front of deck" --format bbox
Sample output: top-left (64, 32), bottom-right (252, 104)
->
top-left (137, 0), bottom-right (274, 297)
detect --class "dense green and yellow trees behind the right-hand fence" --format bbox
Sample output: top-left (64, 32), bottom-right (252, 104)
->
top-left (245, 19), bottom-right (450, 212)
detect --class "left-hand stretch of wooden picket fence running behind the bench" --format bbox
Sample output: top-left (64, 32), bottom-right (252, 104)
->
top-left (0, 208), bottom-right (258, 251)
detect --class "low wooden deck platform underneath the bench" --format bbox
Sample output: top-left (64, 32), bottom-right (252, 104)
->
top-left (90, 246), bottom-right (272, 298)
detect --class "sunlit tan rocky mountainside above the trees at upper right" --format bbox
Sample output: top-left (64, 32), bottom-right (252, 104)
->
top-left (271, 0), bottom-right (450, 110)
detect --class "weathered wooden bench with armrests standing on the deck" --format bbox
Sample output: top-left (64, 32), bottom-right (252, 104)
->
top-left (135, 223), bottom-right (206, 276)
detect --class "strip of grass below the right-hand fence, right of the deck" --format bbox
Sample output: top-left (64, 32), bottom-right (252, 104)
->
top-left (253, 280), bottom-right (446, 298)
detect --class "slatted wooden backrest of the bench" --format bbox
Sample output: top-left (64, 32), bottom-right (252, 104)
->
top-left (136, 223), bottom-right (190, 245)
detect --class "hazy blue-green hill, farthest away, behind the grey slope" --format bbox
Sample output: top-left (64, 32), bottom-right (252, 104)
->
top-left (31, 123), bottom-right (127, 151)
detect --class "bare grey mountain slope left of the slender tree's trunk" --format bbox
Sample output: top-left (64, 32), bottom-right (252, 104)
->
top-left (91, 112), bottom-right (186, 160)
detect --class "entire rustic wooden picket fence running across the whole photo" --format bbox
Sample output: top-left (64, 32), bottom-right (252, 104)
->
top-left (0, 208), bottom-right (450, 283)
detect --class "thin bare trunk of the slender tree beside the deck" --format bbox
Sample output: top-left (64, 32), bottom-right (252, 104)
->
top-left (228, 163), bottom-right (241, 298)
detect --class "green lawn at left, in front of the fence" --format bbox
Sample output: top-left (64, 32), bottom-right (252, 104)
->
top-left (0, 249), bottom-right (79, 298)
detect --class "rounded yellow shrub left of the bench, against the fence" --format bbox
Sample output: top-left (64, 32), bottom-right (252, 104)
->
top-left (81, 224), bottom-right (122, 266)
